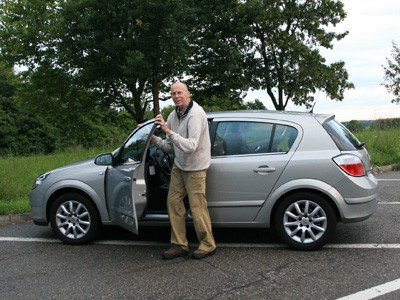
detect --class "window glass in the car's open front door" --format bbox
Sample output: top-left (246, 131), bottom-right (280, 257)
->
top-left (120, 124), bottom-right (153, 163)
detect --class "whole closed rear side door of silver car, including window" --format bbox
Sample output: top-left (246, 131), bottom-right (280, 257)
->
top-left (207, 120), bottom-right (297, 224)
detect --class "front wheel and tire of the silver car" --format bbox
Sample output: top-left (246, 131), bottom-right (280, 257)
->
top-left (50, 193), bottom-right (100, 245)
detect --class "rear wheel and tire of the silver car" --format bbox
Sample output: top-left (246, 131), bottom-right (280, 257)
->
top-left (274, 192), bottom-right (337, 251)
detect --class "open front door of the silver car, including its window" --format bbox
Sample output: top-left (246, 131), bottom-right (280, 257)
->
top-left (106, 123), bottom-right (155, 234)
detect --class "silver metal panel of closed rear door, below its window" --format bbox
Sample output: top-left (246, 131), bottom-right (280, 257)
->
top-left (207, 154), bottom-right (290, 223)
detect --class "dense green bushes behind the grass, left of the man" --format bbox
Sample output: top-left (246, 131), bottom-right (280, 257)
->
top-left (0, 97), bottom-right (136, 157)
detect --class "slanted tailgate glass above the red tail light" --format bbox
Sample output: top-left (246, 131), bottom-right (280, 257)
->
top-left (322, 120), bottom-right (362, 151)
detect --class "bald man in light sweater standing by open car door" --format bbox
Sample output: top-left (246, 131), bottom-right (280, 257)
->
top-left (154, 82), bottom-right (216, 259)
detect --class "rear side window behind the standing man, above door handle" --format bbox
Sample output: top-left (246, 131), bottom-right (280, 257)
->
top-left (212, 122), bottom-right (297, 156)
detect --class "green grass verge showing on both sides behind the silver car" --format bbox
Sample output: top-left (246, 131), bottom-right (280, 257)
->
top-left (0, 128), bottom-right (400, 215)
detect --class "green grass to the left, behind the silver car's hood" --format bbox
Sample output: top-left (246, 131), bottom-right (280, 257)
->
top-left (0, 148), bottom-right (114, 215)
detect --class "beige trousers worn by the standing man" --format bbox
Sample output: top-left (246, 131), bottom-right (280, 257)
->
top-left (167, 165), bottom-right (216, 251)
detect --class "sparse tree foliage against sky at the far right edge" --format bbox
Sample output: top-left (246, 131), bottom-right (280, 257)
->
top-left (383, 42), bottom-right (400, 104)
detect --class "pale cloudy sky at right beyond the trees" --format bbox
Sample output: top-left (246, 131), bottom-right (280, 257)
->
top-left (246, 0), bottom-right (400, 122)
